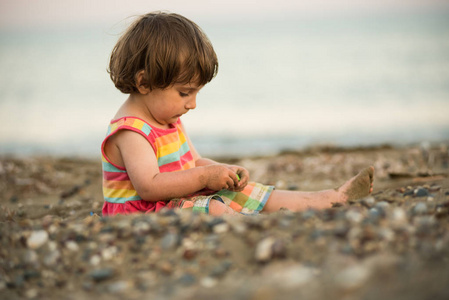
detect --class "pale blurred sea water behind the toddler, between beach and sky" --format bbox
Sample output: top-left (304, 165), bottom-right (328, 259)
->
top-left (0, 11), bottom-right (449, 157)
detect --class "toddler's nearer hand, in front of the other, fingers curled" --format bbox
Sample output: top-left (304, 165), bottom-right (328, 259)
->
top-left (204, 164), bottom-right (239, 191)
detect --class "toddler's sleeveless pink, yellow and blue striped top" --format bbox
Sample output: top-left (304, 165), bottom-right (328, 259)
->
top-left (101, 117), bottom-right (195, 216)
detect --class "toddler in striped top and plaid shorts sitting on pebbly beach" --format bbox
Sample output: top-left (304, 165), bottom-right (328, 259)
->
top-left (101, 12), bottom-right (374, 216)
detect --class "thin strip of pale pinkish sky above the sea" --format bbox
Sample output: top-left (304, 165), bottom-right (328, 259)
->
top-left (0, 0), bottom-right (449, 28)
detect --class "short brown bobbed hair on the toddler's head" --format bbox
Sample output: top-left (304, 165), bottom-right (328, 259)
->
top-left (108, 12), bottom-right (218, 94)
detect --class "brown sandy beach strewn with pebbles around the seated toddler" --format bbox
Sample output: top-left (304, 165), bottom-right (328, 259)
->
top-left (0, 143), bottom-right (449, 300)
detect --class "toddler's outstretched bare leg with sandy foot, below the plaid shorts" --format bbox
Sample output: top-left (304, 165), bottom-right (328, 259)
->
top-left (262, 167), bottom-right (374, 212)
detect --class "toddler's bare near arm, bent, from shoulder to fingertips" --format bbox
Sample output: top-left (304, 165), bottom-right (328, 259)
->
top-left (113, 130), bottom-right (238, 201)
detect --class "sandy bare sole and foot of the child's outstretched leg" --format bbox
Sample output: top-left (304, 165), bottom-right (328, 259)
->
top-left (336, 167), bottom-right (374, 202)
